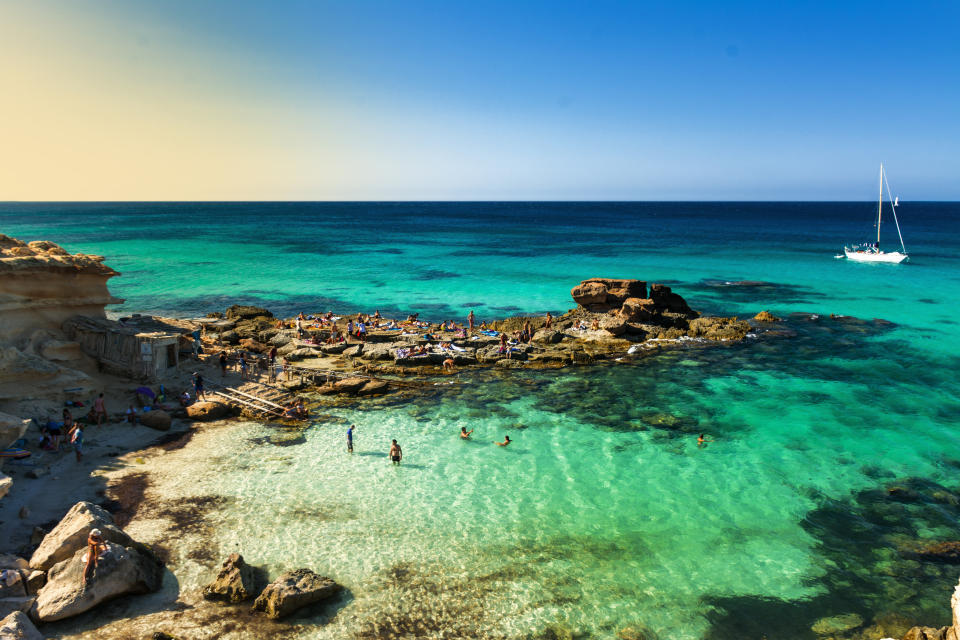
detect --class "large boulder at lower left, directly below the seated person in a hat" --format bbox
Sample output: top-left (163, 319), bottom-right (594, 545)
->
top-left (34, 542), bottom-right (163, 622)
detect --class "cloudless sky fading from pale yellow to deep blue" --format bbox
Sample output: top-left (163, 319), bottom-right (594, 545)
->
top-left (0, 0), bottom-right (960, 201)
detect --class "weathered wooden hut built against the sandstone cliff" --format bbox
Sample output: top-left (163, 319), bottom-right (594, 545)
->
top-left (63, 316), bottom-right (195, 382)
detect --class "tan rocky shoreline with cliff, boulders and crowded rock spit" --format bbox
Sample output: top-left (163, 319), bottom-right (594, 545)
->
top-left (0, 236), bottom-right (944, 640)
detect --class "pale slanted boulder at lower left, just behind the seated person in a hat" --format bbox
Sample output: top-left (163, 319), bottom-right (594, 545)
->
top-left (30, 502), bottom-right (135, 571)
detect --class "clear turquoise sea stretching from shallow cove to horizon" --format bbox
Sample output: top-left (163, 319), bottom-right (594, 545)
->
top-left (0, 202), bottom-right (960, 640)
